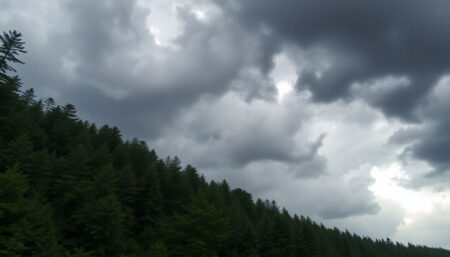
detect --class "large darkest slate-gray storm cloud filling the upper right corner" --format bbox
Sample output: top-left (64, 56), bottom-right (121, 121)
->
top-left (217, 0), bottom-right (450, 120)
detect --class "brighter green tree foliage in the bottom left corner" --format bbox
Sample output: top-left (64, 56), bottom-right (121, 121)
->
top-left (0, 166), bottom-right (60, 257)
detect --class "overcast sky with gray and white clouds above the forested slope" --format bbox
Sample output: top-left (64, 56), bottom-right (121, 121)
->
top-left (0, 0), bottom-right (450, 249)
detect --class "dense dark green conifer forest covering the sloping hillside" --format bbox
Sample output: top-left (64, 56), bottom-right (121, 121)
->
top-left (0, 32), bottom-right (450, 257)
